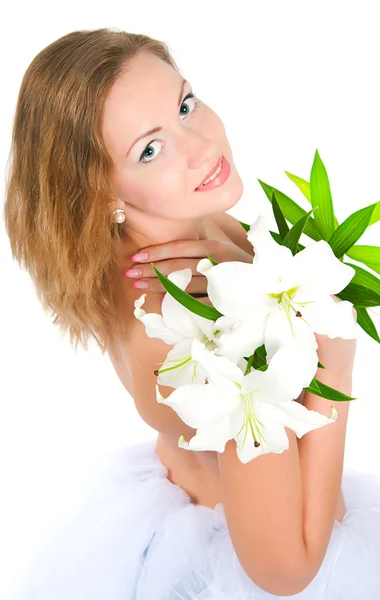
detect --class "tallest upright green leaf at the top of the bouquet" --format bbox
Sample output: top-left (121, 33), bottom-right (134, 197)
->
top-left (310, 150), bottom-right (335, 240)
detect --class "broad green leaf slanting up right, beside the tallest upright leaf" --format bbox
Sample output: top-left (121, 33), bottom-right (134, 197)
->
top-left (328, 203), bottom-right (380, 263)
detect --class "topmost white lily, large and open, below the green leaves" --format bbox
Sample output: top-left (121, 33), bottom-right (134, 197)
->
top-left (197, 216), bottom-right (357, 362)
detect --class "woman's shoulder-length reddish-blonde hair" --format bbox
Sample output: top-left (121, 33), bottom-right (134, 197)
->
top-left (4, 29), bottom-right (179, 353)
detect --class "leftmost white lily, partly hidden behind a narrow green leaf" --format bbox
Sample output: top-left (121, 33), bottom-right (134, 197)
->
top-left (134, 268), bottom-right (216, 388)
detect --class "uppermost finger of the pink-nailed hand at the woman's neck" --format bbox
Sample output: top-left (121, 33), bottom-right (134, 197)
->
top-left (131, 240), bottom-right (226, 263)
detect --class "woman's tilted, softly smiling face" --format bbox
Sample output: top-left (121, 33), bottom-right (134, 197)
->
top-left (103, 53), bottom-right (243, 230)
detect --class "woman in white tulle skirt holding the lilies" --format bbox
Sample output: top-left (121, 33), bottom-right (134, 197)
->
top-left (5, 29), bottom-right (380, 600)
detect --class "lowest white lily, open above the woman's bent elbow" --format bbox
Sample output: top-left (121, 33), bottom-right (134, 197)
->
top-left (156, 339), bottom-right (338, 463)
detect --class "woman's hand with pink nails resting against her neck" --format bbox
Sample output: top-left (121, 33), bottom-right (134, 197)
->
top-left (125, 240), bottom-right (253, 294)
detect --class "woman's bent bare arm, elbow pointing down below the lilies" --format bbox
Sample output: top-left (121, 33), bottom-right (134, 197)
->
top-left (218, 336), bottom-right (355, 595)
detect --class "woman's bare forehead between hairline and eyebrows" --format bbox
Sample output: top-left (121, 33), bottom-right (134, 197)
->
top-left (103, 53), bottom-right (182, 157)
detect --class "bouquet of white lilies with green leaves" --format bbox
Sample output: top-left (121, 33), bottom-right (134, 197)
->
top-left (134, 152), bottom-right (380, 463)
